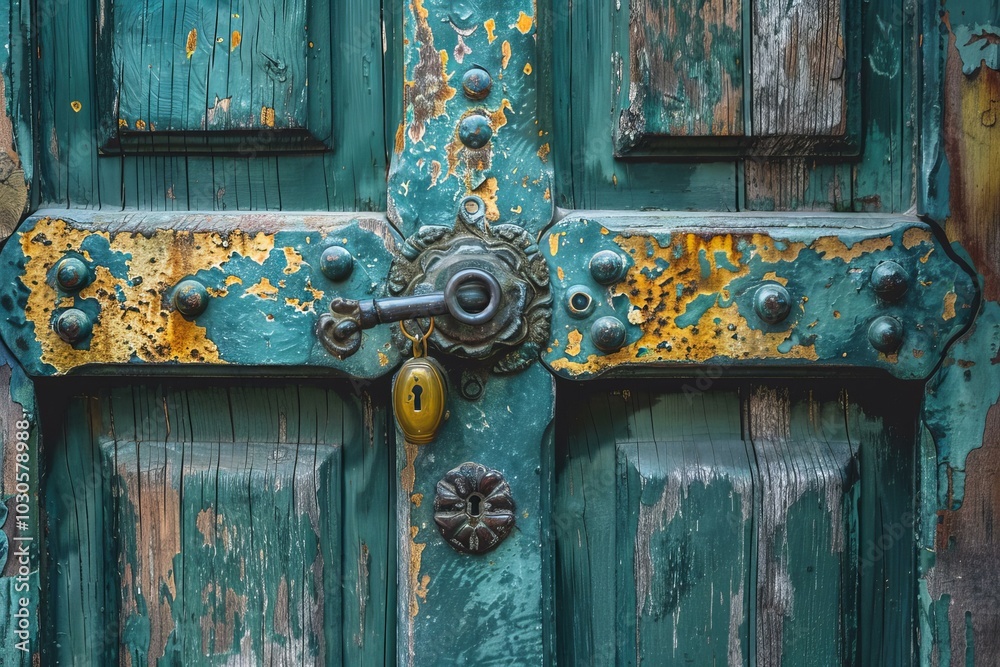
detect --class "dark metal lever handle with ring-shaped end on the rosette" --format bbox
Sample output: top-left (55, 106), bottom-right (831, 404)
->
top-left (317, 268), bottom-right (502, 359)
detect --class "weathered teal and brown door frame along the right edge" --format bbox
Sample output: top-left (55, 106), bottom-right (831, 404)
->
top-left (919, 0), bottom-right (1000, 665)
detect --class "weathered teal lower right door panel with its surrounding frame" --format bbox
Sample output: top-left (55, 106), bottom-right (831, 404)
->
top-left (553, 384), bottom-right (918, 665)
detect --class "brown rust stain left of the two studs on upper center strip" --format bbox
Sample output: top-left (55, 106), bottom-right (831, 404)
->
top-left (406, 0), bottom-right (456, 145)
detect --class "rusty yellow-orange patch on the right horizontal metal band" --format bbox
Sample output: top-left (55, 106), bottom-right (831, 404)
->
top-left (549, 233), bottom-right (817, 375)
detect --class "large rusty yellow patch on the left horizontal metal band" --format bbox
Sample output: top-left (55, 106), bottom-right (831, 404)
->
top-left (21, 218), bottom-right (286, 373)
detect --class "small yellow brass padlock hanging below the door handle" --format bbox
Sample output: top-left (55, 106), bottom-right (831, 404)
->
top-left (392, 357), bottom-right (448, 445)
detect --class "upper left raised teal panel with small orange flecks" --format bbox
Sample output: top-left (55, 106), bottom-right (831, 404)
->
top-left (97, 0), bottom-right (326, 153)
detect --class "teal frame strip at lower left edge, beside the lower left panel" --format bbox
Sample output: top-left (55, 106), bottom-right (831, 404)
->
top-left (0, 344), bottom-right (42, 666)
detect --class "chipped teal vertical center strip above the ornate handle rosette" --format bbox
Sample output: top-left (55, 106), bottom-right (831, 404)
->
top-left (388, 0), bottom-right (553, 236)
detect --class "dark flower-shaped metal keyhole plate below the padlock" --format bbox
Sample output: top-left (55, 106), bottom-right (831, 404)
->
top-left (434, 463), bottom-right (514, 554)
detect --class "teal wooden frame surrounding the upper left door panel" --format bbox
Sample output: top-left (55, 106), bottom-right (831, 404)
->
top-left (35, 0), bottom-right (390, 211)
